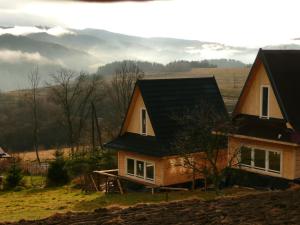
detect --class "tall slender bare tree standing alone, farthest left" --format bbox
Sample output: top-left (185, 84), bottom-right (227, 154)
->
top-left (28, 66), bottom-right (41, 164)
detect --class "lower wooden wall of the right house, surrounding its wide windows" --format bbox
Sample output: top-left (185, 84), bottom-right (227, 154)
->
top-left (228, 137), bottom-right (300, 180)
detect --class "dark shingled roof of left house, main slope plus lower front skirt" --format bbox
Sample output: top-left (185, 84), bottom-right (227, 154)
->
top-left (106, 77), bottom-right (228, 156)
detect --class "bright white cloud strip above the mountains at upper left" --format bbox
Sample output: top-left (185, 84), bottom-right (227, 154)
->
top-left (0, 26), bottom-right (73, 36)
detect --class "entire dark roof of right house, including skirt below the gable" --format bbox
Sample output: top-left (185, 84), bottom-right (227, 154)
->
top-left (234, 49), bottom-right (300, 143)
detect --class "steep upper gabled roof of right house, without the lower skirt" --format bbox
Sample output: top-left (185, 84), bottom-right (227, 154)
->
top-left (234, 49), bottom-right (300, 132)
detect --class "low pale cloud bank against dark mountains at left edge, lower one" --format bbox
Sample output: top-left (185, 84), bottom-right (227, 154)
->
top-left (0, 49), bottom-right (55, 64)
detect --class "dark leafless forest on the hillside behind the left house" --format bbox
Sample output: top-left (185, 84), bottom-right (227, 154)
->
top-left (0, 60), bottom-right (248, 151)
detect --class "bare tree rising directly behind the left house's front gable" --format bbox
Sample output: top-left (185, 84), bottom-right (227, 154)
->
top-left (108, 61), bottom-right (144, 132)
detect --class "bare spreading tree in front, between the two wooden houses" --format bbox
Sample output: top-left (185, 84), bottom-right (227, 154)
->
top-left (172, 103), bottom-right (237, 193)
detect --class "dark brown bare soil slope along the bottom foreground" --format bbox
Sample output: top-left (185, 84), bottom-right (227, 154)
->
top-left (2, 190), bottom-right (300, 225)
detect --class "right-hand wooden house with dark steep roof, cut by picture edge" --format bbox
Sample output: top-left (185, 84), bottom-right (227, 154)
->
top-left (228, 49), bottom-right (300, 180)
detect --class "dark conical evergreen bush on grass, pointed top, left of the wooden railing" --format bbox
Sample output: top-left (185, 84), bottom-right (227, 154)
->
top-left (47, 150), bottom-right (70, 186)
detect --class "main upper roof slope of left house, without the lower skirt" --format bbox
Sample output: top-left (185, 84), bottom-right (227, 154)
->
top-left (137, 77), bottom-right (227, 147)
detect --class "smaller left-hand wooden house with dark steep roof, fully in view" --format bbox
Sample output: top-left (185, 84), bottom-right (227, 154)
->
top-left (106, 77), bottom-right (227, 186)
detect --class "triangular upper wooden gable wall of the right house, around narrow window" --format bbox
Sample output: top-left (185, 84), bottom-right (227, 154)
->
top-left (236, 61), bottom-right (283, 119)
